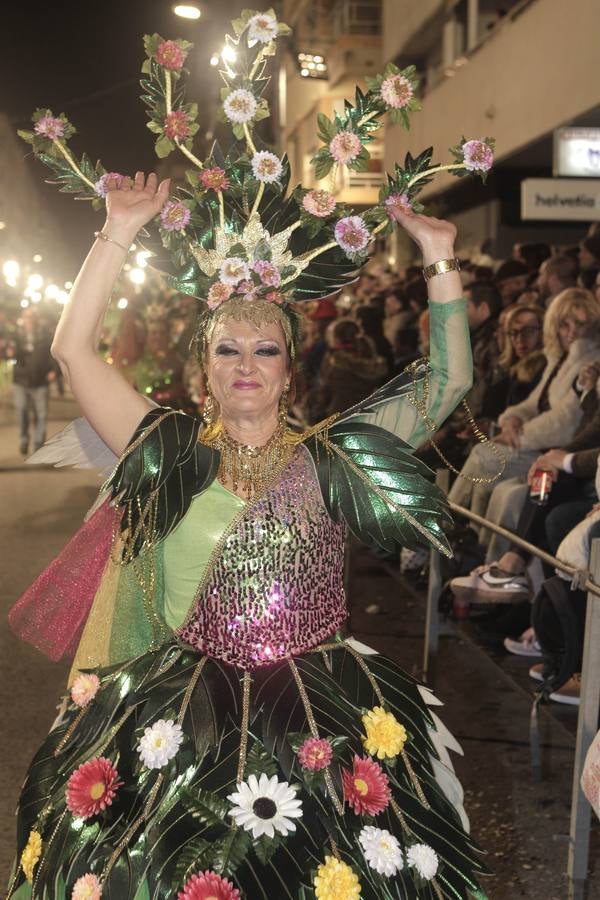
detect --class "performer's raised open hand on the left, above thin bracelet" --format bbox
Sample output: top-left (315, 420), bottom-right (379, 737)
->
top-left (106, 172), bottom-right (171, 240)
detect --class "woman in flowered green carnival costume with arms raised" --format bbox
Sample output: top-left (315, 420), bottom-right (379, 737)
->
top-left (9, 11), bottom-right (492, 900)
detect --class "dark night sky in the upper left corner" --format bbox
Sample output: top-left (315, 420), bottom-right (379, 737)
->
top-left (0, 0), bottom-right (244, 277)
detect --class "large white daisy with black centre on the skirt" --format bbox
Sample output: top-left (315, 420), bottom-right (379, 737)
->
top-left (227, 772), bottom-right (302, 840)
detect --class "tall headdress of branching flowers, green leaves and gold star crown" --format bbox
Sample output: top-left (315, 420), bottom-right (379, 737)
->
top-left (19, 9), bottom-right (494, 355)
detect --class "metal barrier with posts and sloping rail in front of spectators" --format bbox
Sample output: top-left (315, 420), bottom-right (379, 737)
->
top-left (423, 496), bottom-right (600, 900)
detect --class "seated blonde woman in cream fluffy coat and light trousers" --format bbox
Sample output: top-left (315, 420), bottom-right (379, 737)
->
top-left (449, 288), bottom-right (600, 515)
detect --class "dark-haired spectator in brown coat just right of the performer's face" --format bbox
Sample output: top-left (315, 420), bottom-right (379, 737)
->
top-left (311, 319), bottom-right (387, 421)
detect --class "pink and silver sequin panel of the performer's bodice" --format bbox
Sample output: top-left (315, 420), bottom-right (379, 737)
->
top-left (179, 447), bottom-right (346, 669)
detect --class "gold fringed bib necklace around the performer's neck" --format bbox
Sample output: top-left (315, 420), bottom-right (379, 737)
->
top-left (206, 422), bottom-right (298, 500)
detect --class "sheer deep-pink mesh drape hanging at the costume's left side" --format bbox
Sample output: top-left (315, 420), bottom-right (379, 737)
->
top-left (8, 502), bottom-right (115, 661)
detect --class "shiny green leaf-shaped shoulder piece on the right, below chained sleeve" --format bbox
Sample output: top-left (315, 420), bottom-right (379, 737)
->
top-left (305, 419), bottom-right (452, 556)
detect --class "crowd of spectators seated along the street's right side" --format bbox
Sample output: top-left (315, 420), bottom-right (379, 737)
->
top-left (296, 220), bottom-right (600, 704)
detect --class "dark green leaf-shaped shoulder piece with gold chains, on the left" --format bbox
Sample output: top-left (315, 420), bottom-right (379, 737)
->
top-left (107, 407), bottom-right (219, 556)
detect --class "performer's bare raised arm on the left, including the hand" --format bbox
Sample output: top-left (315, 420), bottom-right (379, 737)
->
top-left (52, 172), bottom-right (169, 455)
